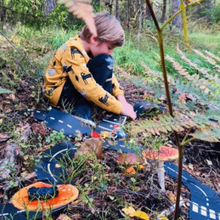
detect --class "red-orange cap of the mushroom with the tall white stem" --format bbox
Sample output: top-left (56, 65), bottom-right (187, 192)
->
top-left (142, 146), bottom-right (179, 161)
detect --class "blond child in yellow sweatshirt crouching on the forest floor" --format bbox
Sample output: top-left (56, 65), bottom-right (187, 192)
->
top-left (44, 13), bottom-right (136, 125)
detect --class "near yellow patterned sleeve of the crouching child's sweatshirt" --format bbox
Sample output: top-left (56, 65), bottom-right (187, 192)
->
top-left (61, 44), bottom-right (122, 114)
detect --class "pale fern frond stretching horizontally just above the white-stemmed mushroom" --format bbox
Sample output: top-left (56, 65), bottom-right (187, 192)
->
top-left (131, 112), bottom-right (220, 142)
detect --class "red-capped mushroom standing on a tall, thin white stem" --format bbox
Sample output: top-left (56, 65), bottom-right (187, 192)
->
top-left (142, 146), bottom-right (178, 191)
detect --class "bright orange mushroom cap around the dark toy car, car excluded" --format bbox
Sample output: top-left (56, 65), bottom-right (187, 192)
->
top-left (12, 182), bottom-right (79, 211)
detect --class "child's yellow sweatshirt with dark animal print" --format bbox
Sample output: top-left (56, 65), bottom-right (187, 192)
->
top-left (44, 36), bottom-right (124, 114)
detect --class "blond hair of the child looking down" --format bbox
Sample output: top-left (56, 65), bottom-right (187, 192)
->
top-left (80, 12), bottom-right (125, 48)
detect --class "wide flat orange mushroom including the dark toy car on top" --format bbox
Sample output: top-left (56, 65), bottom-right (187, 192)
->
top-left (12, 182), bottom-right (79, 216)
